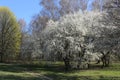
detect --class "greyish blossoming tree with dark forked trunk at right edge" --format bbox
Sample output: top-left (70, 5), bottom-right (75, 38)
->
top-left (94, 0), bottom-right (120, 66)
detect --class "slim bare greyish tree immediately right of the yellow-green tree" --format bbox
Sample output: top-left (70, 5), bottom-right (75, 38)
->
top-left (18, 19), bottom-right (33, 62)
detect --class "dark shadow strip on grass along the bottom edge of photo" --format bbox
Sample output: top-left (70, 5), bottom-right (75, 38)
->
top-left (0, 74), bottom-right (120, 80)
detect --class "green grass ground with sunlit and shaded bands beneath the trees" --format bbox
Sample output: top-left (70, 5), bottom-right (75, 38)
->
top-left (0, 62), bottom-right (120, 80)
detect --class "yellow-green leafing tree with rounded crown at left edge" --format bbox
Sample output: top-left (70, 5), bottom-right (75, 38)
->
top-left (0, 7), bottom-right (21, 59)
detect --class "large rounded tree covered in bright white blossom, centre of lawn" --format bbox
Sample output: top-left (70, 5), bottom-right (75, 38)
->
top-left (39, 12), bottom-right (111, 69)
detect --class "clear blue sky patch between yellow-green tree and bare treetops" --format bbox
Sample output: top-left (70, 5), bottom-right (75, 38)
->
top-left (0, 0), bottom-right (41, 24)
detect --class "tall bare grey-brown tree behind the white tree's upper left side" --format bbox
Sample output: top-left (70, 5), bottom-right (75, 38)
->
top-left (30, 0), bottom-right (59, 34)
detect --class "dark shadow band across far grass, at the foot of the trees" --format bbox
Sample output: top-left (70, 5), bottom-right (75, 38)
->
top-left (0, 63), bottom-right (120, 73)
